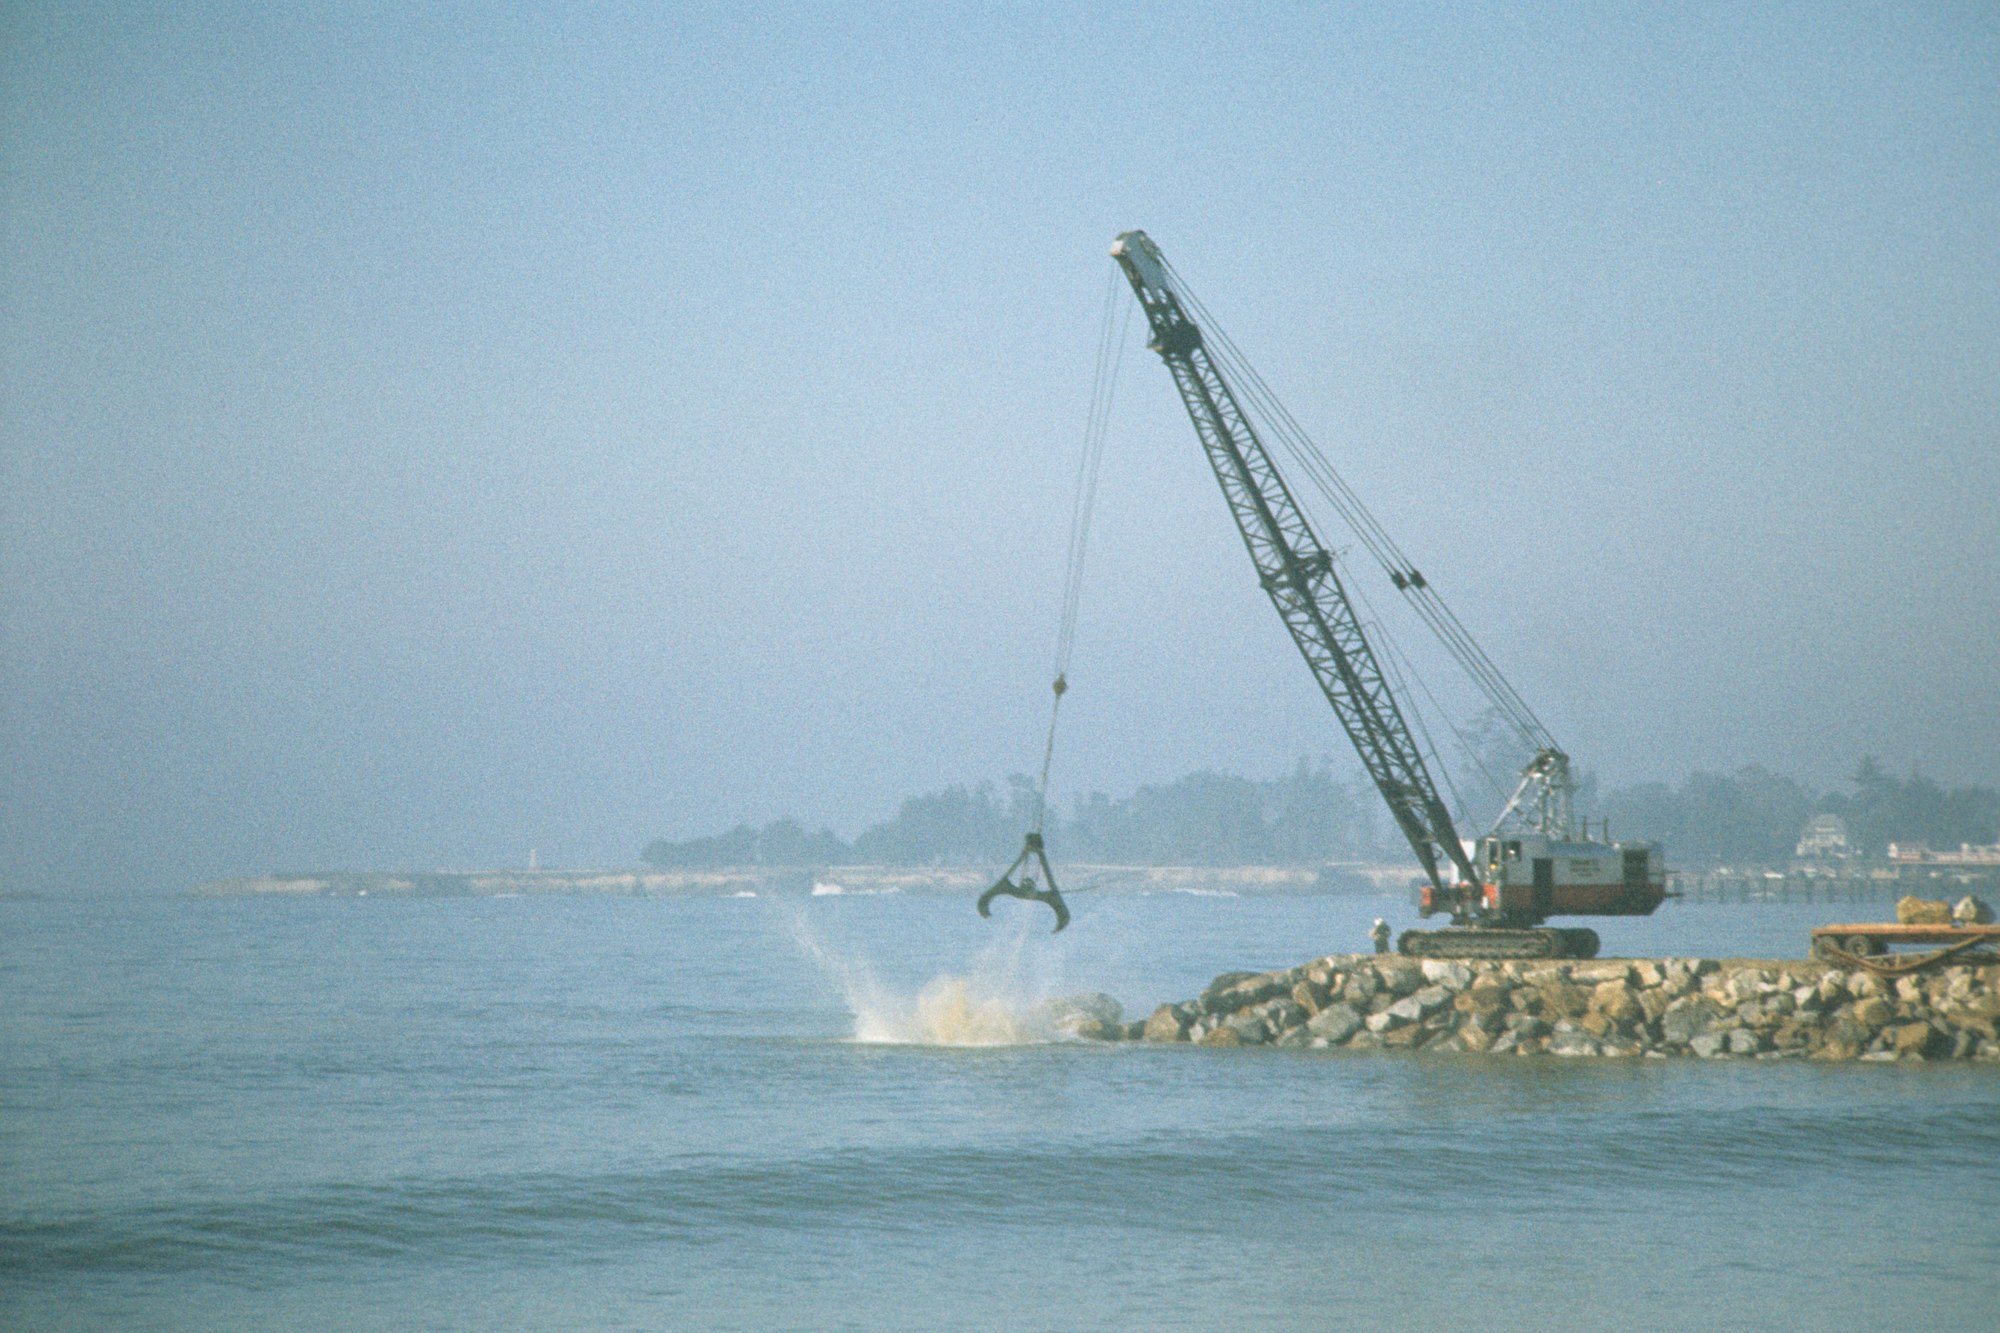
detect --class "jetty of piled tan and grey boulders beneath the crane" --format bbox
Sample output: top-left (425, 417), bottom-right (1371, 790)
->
top-left (1074, 955), bottom-right (2000, 1063)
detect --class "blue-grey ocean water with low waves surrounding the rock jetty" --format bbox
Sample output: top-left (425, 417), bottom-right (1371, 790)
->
top-left (0, 880), bottom-right (2000, 1329)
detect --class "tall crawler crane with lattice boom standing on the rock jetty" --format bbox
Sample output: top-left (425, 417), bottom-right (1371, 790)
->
top-left (1112, 230), bottom-right (1666, 957)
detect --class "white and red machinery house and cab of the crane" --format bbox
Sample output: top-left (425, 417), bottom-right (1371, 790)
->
top-left (1472, 831), bottom-right (1666, 925)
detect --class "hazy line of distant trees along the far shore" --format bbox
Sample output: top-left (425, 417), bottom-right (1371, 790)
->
top-left (644, 757), bottom-right (2000, 869)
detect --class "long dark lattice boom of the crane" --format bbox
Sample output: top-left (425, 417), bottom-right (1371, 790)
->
top-left (1112, 232), bottom-right (1478, 896)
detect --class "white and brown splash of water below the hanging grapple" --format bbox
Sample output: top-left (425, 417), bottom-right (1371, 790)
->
top-left (798, 923), bottom-right (1074, 1047)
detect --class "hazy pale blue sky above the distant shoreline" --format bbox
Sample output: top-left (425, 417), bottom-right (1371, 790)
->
top-left (0, 4), bottom-right (2000, 889)
